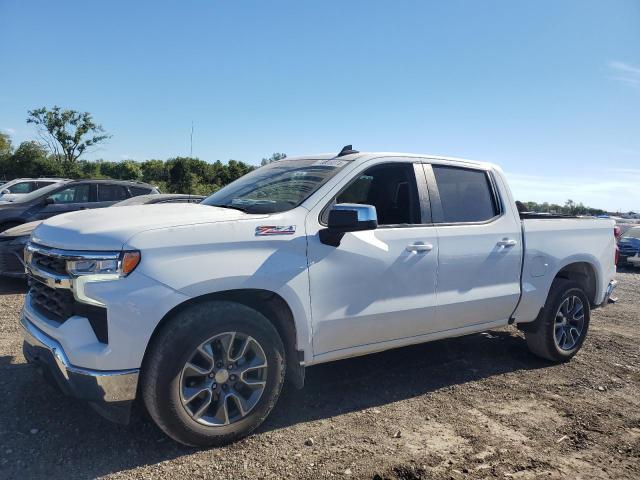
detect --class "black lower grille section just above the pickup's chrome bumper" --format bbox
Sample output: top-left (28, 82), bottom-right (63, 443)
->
top-left (29, 278), bottom-right (109, 343)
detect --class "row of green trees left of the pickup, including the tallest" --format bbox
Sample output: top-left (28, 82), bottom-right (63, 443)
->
top-left (0, 106), bottom-right (276, 195)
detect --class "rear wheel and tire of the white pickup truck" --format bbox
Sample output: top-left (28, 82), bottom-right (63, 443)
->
top-left (525, 278), bottom-right (591, 363)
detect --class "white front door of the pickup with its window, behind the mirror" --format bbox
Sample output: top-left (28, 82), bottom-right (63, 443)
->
top-left (306, 159), bottom-right (438, 356)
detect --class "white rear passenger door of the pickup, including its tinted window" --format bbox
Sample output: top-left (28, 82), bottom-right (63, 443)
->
top-left (425, 164), bottom-right (522, 330)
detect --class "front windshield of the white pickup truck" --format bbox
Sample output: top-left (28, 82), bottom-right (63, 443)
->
top-left (202, 159), bottom-right (348, 213)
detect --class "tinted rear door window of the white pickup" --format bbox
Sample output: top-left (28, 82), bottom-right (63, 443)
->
top-left (432, 165), bottom-right (499, 223)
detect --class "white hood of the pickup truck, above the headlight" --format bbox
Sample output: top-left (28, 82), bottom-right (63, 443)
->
top-left (32, 203), bottom-right (264, 251)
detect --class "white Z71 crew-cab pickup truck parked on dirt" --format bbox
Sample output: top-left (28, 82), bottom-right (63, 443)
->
top-left (21, 146), bottom-right (616, 446)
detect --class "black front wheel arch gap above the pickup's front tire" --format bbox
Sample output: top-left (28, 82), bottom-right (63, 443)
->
top-left (143, 288), bottom-right (304, 388)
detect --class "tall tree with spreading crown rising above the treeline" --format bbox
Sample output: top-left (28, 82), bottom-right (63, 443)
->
top-left (27, 106), bottom-right (110, 173)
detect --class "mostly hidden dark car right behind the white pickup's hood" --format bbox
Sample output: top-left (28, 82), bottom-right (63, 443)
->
top-left (0, 193), bottom-right (199, 278)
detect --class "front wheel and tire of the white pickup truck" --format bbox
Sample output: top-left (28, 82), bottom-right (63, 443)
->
top-left (141, 301), bottom-right (286, 447)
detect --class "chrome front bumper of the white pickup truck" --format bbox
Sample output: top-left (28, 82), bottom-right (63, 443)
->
top-left (20, 316), bottom-right (140, 423)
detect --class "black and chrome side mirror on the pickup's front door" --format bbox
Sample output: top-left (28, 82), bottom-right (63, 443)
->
top-left (320, 203), bottom-right (378, 247)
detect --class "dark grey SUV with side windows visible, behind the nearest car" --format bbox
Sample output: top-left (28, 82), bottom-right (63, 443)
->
top-left (0, 180), bottom-right (159, 232)
